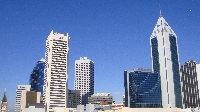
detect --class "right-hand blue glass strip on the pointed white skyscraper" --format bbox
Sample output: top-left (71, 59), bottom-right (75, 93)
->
top-left (169, 34), bottom-right (182, 108)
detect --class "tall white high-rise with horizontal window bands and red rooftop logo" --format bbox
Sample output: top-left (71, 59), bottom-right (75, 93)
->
top-left (43, 31), bottom-right (70, 112)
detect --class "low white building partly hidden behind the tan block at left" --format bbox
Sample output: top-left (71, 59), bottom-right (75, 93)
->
top-left (15, 85), bottom-right (31, 112)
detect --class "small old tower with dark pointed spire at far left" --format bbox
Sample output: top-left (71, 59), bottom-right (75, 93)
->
top-left (0, 92), bottom-right (8, 112)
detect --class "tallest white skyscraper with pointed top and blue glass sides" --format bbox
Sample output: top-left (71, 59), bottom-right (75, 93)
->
top-left (150, 11), bottom-right (182, 108)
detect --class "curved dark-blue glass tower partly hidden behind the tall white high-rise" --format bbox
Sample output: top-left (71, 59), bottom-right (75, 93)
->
top-left (29, 58), bottom-right (45, 96)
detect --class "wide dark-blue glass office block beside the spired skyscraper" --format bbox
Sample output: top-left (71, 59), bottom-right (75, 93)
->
top-left (124, 68), bottom-right (162, 108)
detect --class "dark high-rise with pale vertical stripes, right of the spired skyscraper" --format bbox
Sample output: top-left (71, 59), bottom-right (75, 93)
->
top-left (180, 60), bottom-right (200, 108)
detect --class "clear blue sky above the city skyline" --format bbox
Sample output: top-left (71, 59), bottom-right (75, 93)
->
top-left (0, 0), bottom-right (200, 111)
